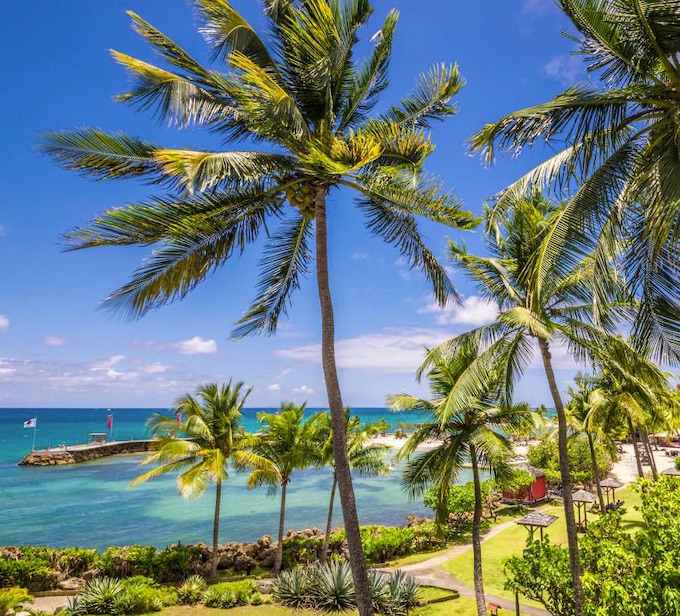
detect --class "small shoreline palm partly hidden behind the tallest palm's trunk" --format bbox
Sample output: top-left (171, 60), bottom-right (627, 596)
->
top-left (320, 408), bottom-right (390, 562)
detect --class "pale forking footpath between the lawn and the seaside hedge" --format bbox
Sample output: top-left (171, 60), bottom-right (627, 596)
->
top-left (380, 520), bottom-right (550, 616)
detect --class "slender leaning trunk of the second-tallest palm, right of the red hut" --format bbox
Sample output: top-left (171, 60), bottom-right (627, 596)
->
top-left (538, 338), bottom-right (584, 616)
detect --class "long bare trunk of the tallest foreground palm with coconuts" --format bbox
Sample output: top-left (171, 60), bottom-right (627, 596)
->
top-left (314, 186), bottom-right (373, 616)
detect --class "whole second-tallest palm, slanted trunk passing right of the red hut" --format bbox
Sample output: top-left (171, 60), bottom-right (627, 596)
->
top-left (430, 192), bottom-right (625, 616)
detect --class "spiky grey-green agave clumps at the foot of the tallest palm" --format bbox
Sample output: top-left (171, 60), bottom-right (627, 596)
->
top-left (272, 562), bottom-right (419, 616)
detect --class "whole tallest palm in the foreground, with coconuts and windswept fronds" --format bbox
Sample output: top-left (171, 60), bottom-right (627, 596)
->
top-left (43, 0), bottom-right (476, 615)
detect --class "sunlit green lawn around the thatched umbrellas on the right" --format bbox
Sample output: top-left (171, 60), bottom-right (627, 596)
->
top-left (443, 488), bottom-right (642, 607)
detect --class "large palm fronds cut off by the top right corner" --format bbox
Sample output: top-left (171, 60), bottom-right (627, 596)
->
top-left (471, 0), bottom-right (680, 363)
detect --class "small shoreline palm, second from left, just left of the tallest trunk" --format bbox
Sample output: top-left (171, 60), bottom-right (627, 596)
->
top-left (248, 402), bottom-right (322, 575)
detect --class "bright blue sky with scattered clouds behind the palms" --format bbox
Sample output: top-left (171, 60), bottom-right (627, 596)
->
top-left (0, 0), bottom-right (585, 407)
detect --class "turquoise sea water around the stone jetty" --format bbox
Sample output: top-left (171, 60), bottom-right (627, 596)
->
top-left (0, 408), bottom-right (470, 548)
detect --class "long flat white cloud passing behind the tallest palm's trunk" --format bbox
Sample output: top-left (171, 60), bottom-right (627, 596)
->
top-left (276, 328), bottom-right (451, 373)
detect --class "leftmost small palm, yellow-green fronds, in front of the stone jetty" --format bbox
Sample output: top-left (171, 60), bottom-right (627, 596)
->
top-left (130, 381), bottom-right (276, 581)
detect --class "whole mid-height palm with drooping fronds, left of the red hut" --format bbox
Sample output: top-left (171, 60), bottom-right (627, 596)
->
top-left (388, 341), bottom-right (532, 616)
